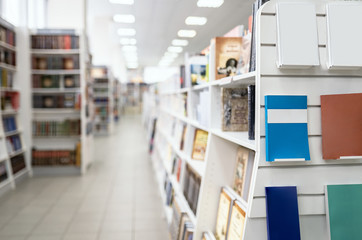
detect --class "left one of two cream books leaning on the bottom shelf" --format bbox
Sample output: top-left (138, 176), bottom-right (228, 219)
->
top-left (215, 188), bottom-right (233, 240)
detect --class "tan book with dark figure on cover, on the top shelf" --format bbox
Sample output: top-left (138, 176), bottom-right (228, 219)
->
top-left (215, 37), bottom-right (242, 80)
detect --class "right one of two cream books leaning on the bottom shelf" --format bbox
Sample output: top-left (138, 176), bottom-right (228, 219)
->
top-left (227, 201), bottom-right (246, 240)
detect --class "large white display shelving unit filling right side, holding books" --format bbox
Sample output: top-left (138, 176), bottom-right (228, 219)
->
top-left (144, 0), bottom-right (362, 240)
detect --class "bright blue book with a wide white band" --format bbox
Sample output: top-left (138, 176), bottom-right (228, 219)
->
top-left (265, 96), bottom-right (310, 162)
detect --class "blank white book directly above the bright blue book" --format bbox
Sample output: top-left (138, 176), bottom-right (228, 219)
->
top-left (276, 3), bottom-right (319, 68)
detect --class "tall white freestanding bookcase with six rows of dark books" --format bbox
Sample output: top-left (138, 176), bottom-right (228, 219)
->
top-left (30, 29), bottom-right (93, 175)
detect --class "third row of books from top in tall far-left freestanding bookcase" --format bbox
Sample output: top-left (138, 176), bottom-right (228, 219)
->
top-left (32, 74), bottom-right (80, 88)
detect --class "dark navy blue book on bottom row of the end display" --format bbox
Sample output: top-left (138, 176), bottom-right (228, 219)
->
top-left (265, 186), bottom-right (300, 240)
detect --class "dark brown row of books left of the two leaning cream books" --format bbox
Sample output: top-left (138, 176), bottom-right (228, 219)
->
top-left (183, 165), bottom-right (201, 215)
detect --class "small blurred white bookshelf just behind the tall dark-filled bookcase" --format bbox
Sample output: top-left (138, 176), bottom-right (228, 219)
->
top-left (92, 66), bottom-right (114, 135)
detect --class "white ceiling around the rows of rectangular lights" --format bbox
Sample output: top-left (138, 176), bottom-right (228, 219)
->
top-left (88, 0), bottom-right (254, 67)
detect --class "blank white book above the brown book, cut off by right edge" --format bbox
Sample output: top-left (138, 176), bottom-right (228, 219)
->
top-left (327, 2), bottom-right (362, 69)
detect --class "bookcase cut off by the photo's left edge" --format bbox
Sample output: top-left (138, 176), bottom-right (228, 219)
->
top-left (0, 18), bottom-right (31, 191)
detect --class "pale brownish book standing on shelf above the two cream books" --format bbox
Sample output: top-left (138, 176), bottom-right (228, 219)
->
top-left (233, 147), bottom-right (249, 197)
